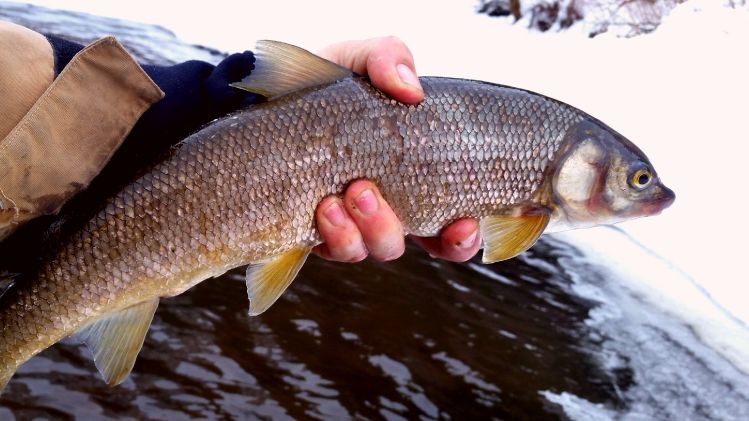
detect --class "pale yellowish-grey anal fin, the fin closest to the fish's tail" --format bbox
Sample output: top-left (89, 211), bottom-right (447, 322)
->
top-left (75, 299), bottom-right (159, 386)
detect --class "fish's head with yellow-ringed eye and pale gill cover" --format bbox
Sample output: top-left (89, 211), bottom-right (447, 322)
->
top-left (551, 119), bottom-right (676, 228)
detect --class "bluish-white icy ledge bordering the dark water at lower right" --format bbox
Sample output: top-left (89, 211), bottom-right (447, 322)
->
top-left (540, 229), bottom-right (749, 420)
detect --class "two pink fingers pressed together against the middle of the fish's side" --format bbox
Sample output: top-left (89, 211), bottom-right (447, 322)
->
top-left (314, 180), bottom-right (405, 262)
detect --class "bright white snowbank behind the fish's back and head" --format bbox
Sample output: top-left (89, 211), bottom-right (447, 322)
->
top-left (14, 0), bottom-right (749, 401)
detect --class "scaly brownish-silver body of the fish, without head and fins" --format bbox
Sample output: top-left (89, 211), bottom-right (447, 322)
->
top-left (0, 55), bottom-right (672, 386)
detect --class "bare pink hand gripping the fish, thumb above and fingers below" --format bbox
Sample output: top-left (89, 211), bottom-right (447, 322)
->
top-left (314, 37), bottom-right (481, 262)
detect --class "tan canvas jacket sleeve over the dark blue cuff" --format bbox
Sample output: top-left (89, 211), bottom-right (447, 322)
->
top-left (0, 22), bottom-right (164, 240)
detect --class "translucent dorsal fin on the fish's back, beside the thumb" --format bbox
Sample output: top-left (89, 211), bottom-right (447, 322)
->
top-left (231, 40), bottom-right (354, 98)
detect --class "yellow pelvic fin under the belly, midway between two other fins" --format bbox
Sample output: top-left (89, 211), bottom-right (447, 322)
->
top-left (246, 248), bottom-right (312, 316)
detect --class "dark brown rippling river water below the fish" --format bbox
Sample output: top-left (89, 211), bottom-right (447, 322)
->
top-left (2, 238), bottom-right (617, 419)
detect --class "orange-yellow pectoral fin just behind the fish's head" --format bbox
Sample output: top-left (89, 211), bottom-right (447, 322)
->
top-left (481, 212), bottom-right (549, 263)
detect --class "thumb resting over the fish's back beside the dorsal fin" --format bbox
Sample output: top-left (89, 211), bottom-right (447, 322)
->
top-left (320, 37), bottom-right (424, 104)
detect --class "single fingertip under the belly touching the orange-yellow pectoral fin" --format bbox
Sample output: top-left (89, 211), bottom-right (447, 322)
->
top-left (413, 218), bottom-right (481, 262)
